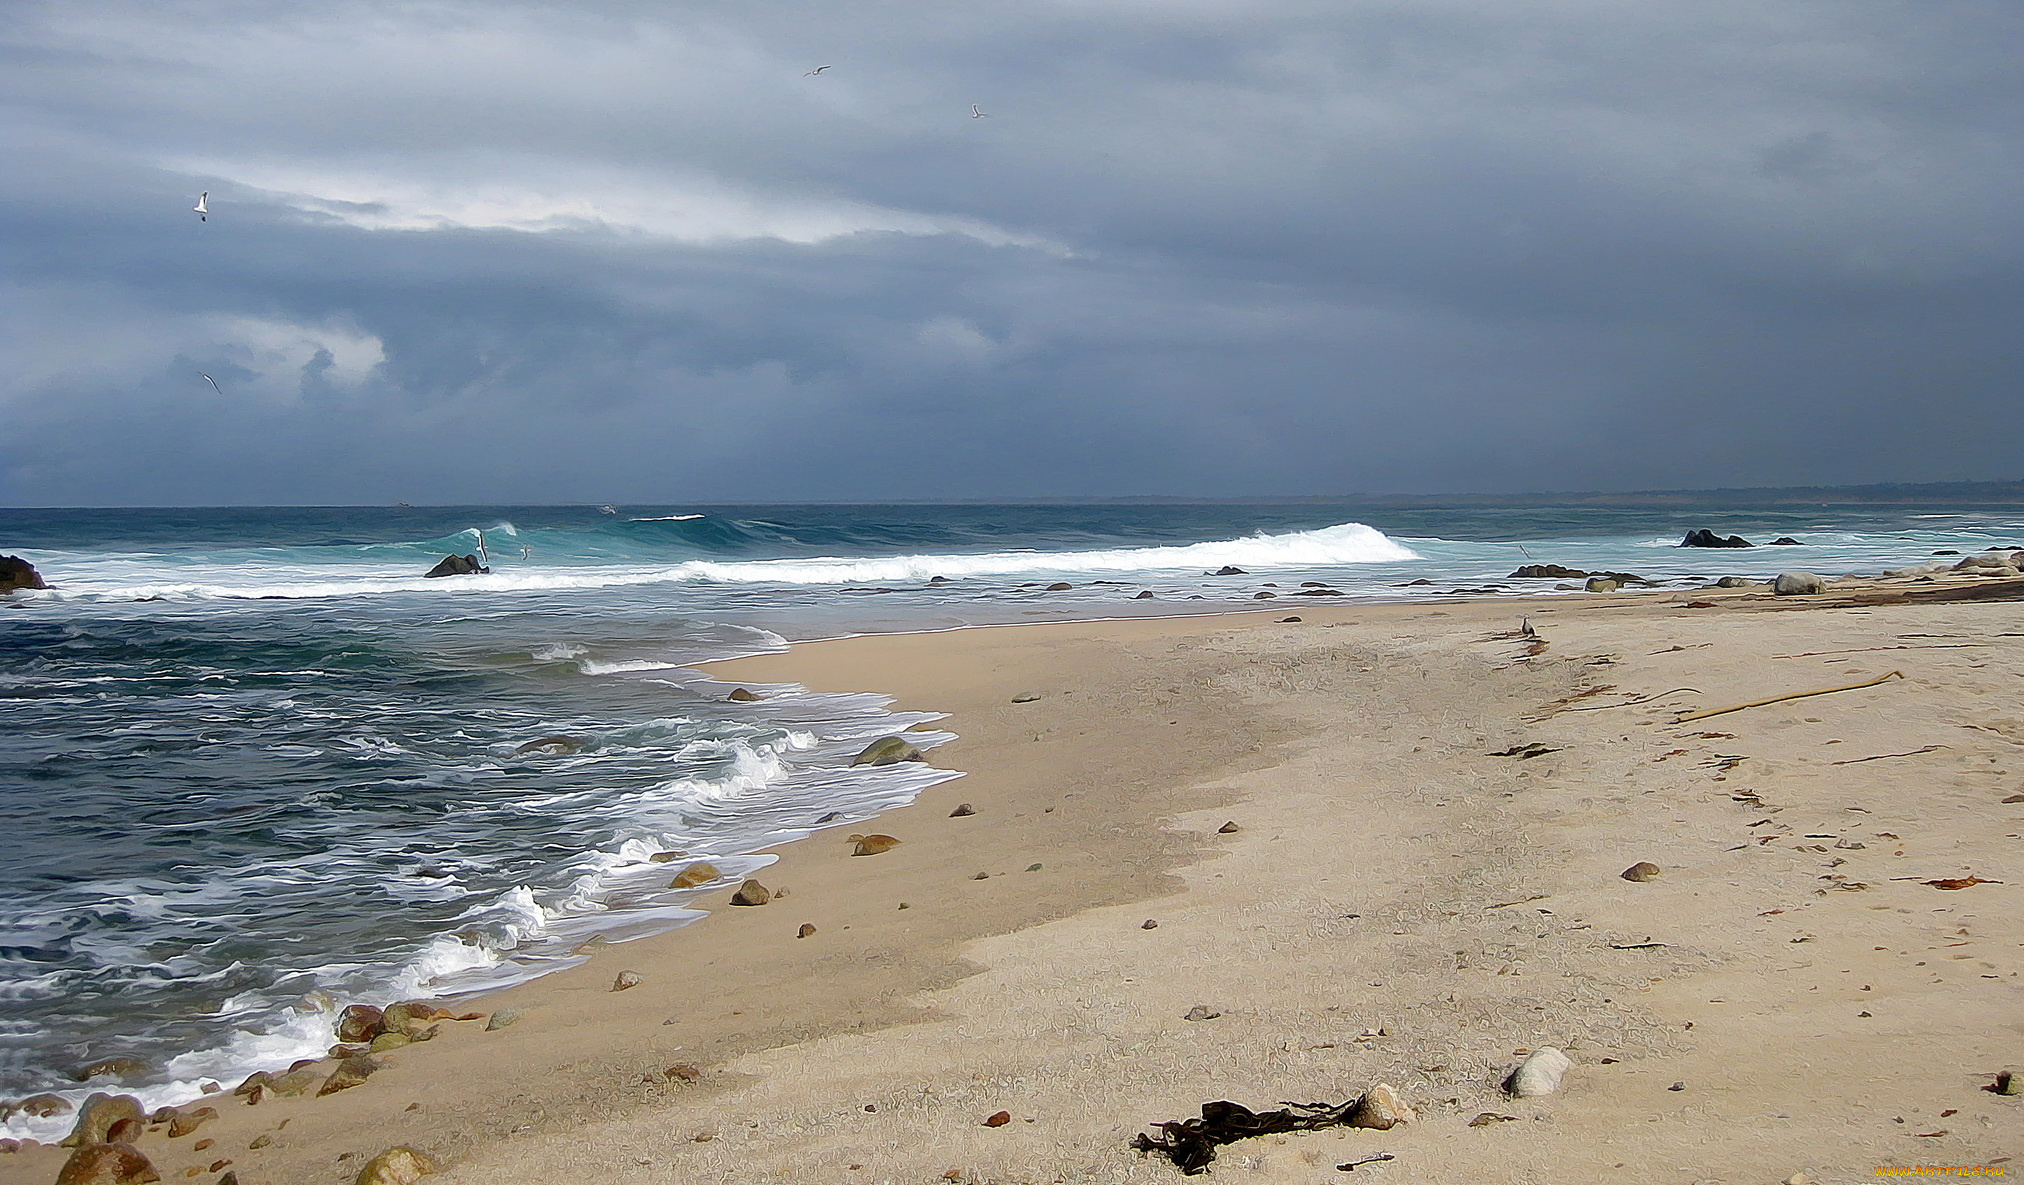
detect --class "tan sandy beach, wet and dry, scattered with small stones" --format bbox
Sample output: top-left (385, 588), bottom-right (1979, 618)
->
top-left (15, 591), bottom-right (2024, 1185)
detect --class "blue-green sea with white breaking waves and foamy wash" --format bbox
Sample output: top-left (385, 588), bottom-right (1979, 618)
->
top-left (0, 496), bottom-right (2024, 1138)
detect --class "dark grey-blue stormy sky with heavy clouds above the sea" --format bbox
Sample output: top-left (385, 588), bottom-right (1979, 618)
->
top-left (0, 0), bottom-right (2024, 504)
